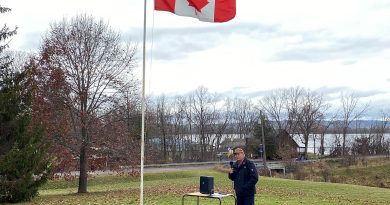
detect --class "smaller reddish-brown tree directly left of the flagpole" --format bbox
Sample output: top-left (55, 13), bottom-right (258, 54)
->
top-left (102, 79), bottom-right (141, 173)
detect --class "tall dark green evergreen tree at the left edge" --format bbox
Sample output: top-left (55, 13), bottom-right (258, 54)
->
top-left (0, 7), bottom-right (52, 203)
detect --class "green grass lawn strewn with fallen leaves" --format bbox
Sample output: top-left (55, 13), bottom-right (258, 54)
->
top-left (20, 170), bottom-right (390, 205)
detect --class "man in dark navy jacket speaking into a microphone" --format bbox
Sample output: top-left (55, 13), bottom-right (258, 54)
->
top-left (229, 148), bottom-right (259, 205)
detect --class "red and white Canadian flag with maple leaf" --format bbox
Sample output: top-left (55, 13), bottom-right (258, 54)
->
top-left (154, 0), bottom-right (236, 22)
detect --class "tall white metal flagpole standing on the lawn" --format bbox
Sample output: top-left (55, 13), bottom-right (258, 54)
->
top-left (139, 0), bottom-right (147, 205)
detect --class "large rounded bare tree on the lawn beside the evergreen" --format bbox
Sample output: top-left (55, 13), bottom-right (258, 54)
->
top-left (41, 14), bottom-right (136, 193)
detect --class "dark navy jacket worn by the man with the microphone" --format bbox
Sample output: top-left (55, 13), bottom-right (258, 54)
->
top-left (229, 158), bottom-right (259, 196)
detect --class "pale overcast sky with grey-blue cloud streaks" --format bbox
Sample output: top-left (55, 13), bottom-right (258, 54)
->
top-left (0, 0), bottom-right (390, 117)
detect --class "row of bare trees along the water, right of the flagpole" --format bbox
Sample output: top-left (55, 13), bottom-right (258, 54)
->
top-left (147, 87), bottom-right (389, 162)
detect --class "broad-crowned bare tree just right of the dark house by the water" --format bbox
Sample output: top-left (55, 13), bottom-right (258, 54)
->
top-left (260, 87), bottom-right (328, 158)
